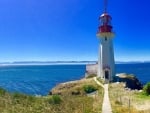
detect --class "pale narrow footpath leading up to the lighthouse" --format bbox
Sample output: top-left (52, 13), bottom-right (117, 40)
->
top-left (94, 77), bottom-right (112, 113)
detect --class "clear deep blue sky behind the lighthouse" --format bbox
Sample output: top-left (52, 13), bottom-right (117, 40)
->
top-left (0, 0), bottom-right (150, 62)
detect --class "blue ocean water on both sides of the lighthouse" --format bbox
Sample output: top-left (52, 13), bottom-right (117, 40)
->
top-left (0, 63), bottom-right (150, 95)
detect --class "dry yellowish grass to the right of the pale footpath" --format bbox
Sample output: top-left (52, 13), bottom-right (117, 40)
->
top-left (109, 83), bottom-right (150, 113)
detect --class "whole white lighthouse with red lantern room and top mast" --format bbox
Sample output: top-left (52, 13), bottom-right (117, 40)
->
top-left (97, 0), bottom-right (115, 82)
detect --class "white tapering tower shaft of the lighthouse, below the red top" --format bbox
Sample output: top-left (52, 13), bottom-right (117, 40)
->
top-left (98, 37), bottom-right (115, 82)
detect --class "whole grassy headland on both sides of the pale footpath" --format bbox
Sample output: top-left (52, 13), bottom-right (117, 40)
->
top-left (0, 78), bottom-right (150, 113)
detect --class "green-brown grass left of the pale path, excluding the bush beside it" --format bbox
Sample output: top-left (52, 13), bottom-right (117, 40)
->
top-left (0, 79), bottom-right (103, 113)
